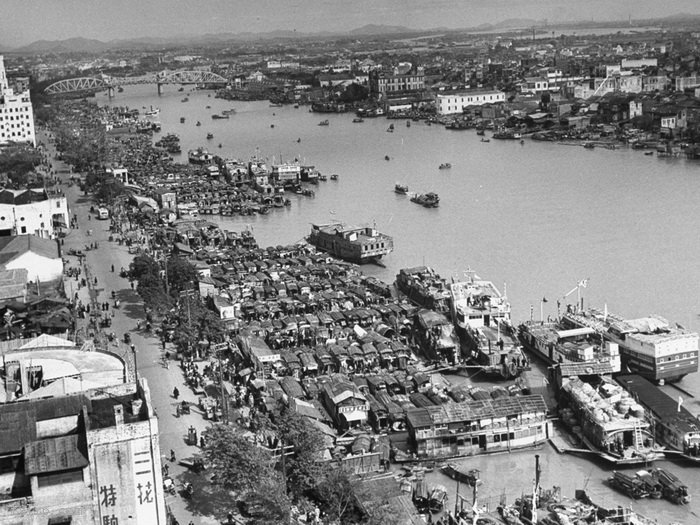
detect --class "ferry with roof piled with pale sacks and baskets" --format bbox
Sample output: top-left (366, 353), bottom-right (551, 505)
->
top-left (559, 376), bottom-right (664, 465)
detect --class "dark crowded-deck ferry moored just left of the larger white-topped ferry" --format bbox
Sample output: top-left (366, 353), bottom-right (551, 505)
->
top-left (396, 266), bottom-right (450, 314)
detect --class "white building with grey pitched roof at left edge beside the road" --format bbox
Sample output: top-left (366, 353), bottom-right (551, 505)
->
top-left (0, 235), bottom-right (63, 282)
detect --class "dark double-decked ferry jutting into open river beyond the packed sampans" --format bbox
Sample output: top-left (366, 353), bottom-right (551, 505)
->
top-left (307, 223), bottom-right (394, 264)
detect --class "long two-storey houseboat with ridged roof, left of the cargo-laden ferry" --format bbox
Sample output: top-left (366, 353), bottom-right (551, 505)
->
top-left (406, 395), bottom-right (549, 457)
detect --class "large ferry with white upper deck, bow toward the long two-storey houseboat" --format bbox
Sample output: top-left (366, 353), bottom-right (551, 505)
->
top-left (450, 272), bottom-right (529, 379)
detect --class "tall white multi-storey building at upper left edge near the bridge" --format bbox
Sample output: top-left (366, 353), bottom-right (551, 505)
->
top-left (0, 55), bottom-right (36, 146)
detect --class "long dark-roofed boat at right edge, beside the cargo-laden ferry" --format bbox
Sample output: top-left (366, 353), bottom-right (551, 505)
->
top-left (615, 374), bottom-right (700, 463)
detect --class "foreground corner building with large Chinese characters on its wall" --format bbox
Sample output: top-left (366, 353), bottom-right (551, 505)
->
top-left (0, 379), bottom-right (167, 525)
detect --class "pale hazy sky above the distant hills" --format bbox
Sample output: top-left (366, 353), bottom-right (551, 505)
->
top-left (0, 0), bottom-right (700, 48)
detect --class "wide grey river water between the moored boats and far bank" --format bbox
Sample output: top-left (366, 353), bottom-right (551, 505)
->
top-left (105, 86), bottom-right (700, 524)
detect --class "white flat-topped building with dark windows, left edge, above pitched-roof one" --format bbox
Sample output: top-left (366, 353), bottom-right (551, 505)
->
top-left (0, 189), bottom-right (70, 239)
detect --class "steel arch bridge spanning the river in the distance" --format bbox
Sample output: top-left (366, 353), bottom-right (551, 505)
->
top-left (44, 71), bottom-right (228, 95)
